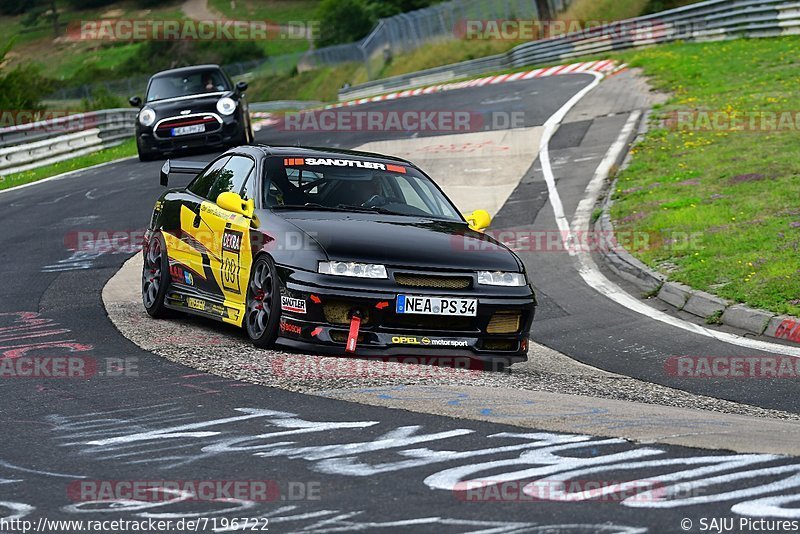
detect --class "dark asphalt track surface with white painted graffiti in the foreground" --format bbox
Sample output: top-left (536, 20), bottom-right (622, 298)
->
top-left (0, 75), bottom-right (800, 532)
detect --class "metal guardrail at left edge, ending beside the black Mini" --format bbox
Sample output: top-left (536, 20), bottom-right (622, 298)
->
top-left (0, 108), bottom-right (137, 176)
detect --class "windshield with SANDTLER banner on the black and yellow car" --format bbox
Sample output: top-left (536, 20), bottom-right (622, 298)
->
top-left (264, 158), bottom-right (463, 222)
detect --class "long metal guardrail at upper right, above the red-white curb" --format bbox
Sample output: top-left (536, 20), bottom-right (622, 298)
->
top-left (339, 0), bottom-right (800, 101)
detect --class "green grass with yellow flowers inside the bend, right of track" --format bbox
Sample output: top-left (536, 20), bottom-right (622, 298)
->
top-left (611, 37), bottom-right (800, 315)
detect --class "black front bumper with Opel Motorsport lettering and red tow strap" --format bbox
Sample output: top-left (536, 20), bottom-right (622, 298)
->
top-left (277, 266), bottom-right (536, 362)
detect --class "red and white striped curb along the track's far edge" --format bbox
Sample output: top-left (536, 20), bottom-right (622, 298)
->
top-left (251, 59), bottom-right (625, 131)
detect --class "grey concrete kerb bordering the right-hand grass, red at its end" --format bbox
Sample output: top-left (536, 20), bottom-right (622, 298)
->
top-left (594, 116), bottom-right (800, 343)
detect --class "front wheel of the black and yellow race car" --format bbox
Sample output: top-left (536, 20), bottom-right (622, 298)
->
top-left (243, 255), bottom-right (281, 349)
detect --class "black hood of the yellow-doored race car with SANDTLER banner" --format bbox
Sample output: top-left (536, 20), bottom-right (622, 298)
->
top-left (273, 212), bottom-right (522, 272)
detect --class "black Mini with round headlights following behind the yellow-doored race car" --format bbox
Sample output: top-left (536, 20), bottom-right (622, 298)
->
top-left (129, 65), bottom-right (253, 161)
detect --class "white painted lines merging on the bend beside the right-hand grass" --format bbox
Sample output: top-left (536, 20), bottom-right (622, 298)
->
top-left (539, 82), bottom-right (800, 358)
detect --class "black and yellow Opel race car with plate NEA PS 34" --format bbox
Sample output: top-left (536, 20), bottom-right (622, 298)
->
top-left (142, 145), bottom-right (536, 362)
